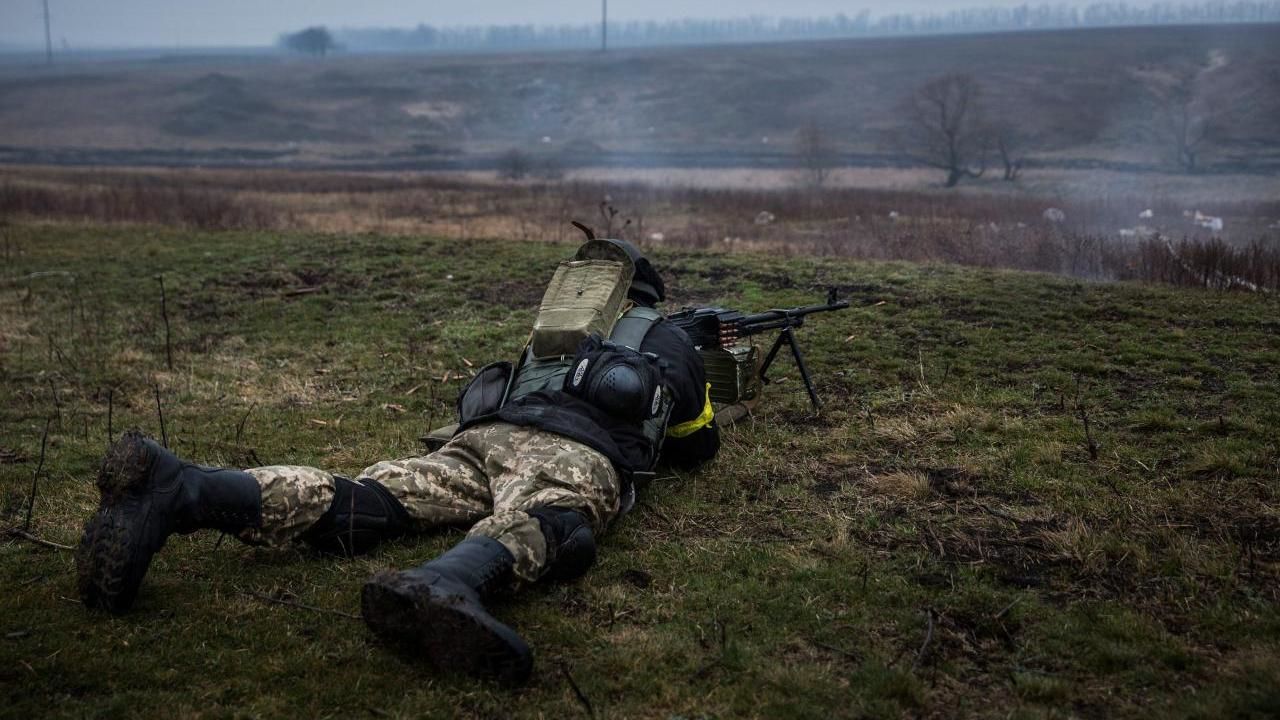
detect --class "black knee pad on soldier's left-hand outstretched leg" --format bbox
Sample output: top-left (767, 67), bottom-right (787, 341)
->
top-left (301, 475), bottom-right (411, 556)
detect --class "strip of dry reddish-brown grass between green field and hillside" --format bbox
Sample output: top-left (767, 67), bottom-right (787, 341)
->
top-left (0, 168), bottom-right (1280, 292)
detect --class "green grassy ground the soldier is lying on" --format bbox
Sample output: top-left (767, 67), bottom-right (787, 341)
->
top-left (0, 223), bottom-right (1280, 717)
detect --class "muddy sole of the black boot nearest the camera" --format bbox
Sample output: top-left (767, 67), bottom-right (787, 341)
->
top-left (360, 573), bottom-right (532, 684)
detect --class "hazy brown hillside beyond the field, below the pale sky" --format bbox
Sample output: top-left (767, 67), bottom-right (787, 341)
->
top-left (0, 26), bottom-right (1280, 172)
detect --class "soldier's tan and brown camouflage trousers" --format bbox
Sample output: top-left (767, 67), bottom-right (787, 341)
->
top-left (246, 423), bottom-right (622, 582)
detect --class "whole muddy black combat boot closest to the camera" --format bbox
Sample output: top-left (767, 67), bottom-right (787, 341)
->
top-left (360, 537), bottom-right (534, 684)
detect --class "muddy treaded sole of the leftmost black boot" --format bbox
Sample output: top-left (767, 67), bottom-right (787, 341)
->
top-left (76, 430), bottom-right (151, 612)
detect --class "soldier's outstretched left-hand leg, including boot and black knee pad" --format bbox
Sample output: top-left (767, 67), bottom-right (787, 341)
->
top-left (76, 432), bottom-right (489, 612)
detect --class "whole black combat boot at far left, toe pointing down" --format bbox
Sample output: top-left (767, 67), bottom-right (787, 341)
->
top-left (76, 430), bottom-right (262, 612)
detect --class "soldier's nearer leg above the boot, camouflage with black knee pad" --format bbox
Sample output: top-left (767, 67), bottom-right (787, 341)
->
top-left (468, 425), bottom-right (622, 583)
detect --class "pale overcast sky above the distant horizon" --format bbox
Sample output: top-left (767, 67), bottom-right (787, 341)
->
top-left (0, 0), bottom-right (1070, 49)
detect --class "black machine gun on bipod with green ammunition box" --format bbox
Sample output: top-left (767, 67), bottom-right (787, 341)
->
top-left (667, 288), bottom-right (849, 410)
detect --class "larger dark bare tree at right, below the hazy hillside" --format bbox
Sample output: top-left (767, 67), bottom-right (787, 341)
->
top-left (895, 74), bottom-right (991, 187)
